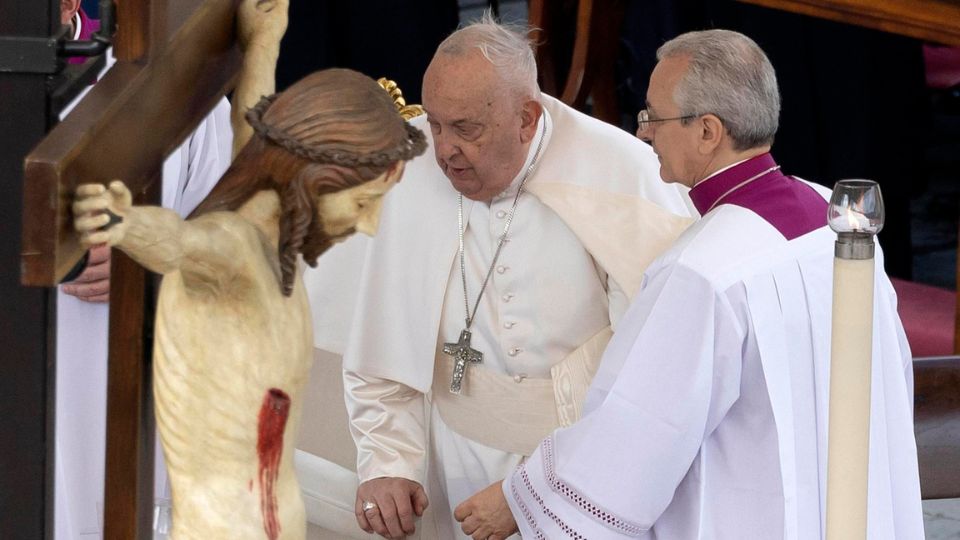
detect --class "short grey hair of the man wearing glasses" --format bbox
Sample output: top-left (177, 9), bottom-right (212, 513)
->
top-left (657, 30), bottom-right (780, 150)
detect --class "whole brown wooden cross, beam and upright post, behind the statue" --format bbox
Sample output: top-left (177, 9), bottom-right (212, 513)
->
top-left (21, 0), bottom-right (241, 540)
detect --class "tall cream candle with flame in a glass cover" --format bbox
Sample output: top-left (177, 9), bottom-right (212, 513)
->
top-left (827, 180), bottom-right (884, 540)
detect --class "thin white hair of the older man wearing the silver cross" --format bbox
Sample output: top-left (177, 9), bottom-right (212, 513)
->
top-left (437, 10), bottom-right (540, 99)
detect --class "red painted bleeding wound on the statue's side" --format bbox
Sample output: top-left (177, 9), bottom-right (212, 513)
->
top-left (257, 388), bottom-right (290, 540)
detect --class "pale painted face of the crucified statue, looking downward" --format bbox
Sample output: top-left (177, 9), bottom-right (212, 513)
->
top-left (317, 162), bottom-right (404, 243)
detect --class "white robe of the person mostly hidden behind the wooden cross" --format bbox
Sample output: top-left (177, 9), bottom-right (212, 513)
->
top-left (54, 51), bottom-right (233, 540)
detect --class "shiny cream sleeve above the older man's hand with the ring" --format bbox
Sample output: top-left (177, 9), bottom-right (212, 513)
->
top-left (343, 370), bottom-right (427, 485)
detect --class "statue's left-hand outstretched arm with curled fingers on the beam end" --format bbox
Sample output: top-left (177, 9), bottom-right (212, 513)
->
top-left (73, 180), bottom-right (248, 282)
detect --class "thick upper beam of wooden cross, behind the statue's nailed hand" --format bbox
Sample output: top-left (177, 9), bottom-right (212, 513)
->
top-left (21, 0), bottom-right (241, 287)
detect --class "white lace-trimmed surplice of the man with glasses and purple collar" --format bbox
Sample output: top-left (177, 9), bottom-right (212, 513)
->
top-left (503, 201), bottom-right (923, 540)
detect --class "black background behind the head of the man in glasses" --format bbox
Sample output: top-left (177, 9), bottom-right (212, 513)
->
top-left (620, 0), bottom-right (960, 287)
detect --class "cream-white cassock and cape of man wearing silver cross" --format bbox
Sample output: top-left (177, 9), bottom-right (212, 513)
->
top-left (334, 96), bottom-right (689, 539)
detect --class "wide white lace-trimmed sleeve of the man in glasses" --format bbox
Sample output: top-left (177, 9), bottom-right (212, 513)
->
top-left (504, 267), bottom-right (744, 539)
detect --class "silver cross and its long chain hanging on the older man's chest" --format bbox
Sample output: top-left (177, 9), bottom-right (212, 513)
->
top-left (443, 119), bottom-right (547, 394)
